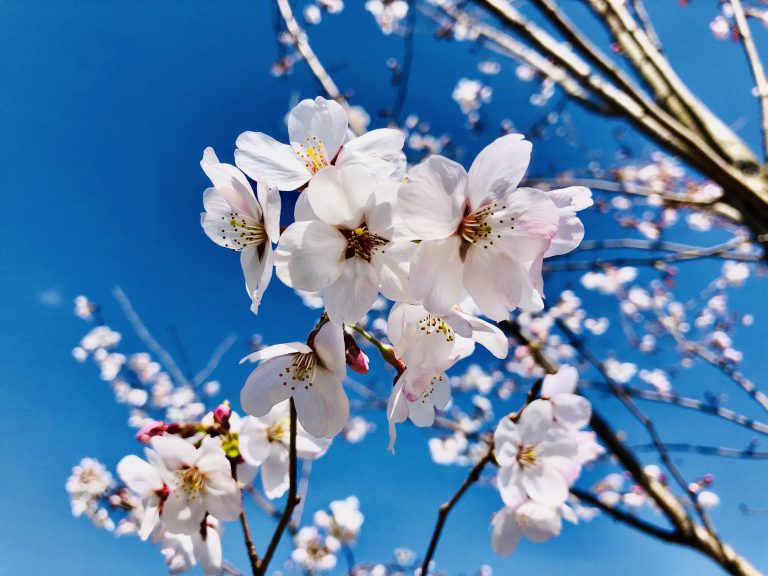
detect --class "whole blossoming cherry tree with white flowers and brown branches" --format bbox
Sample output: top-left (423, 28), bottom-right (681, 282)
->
top-left (66, 0), bottom-right (768, 576)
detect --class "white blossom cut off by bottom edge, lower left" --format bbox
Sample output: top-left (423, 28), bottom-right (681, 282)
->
top-left (160, 516), bottom-right (224, 576)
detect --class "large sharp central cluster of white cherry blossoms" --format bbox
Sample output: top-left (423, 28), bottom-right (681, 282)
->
top-left (202, 97), bottom-right (591, 439)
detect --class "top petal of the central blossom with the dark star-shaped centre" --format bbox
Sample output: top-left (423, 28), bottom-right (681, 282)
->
top-left (305, 166), bottom-right (376, 230)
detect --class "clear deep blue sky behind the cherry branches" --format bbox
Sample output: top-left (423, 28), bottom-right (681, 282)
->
top-left (0, 0), bottom-right (768, 576)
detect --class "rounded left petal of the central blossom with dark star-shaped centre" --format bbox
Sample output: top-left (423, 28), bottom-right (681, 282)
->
top-left (275, 222), bottom-right (347, 292)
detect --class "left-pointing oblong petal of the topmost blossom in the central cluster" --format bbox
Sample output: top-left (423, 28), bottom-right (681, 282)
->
top-left (235, 132), bottom-right (311, 190)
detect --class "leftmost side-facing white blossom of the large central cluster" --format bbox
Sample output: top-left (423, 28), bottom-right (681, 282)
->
top-left (200, 148), bottom-right (280, 314)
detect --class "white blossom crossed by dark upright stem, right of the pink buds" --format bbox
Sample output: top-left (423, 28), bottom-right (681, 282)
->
top-left (238, 400), bottom-right (331, 498)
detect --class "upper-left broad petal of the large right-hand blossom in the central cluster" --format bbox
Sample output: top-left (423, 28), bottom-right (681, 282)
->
top-left (397, 155), bottom-right (467, 240)
